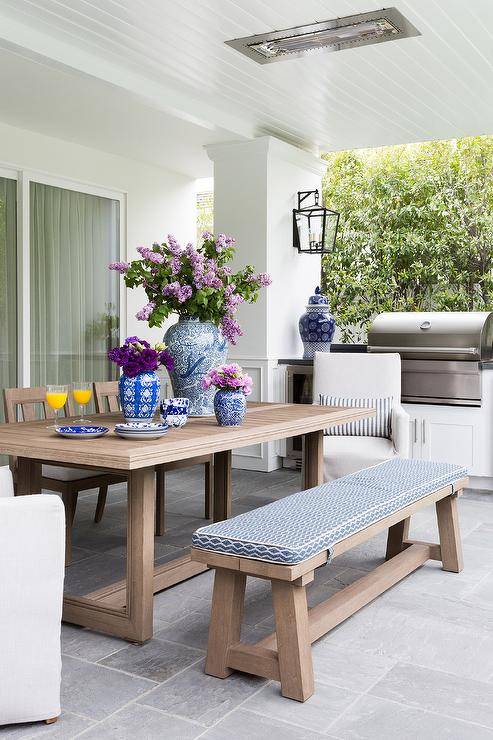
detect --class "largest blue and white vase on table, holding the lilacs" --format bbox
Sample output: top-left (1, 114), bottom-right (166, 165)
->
top-left (164, 318), bottom-right (228, 416)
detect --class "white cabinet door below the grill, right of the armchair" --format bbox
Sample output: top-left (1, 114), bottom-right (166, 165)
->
top-left (421, 419), bottom-right (474, 468)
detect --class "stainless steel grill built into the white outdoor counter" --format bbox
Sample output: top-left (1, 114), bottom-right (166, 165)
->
top-left (368, 311), bottom-right (493, 406)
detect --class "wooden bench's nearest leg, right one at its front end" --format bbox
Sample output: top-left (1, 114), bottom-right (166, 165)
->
top-left (272, 580), bottom-right (314, 701)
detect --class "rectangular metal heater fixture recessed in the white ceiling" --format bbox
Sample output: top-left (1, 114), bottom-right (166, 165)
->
top-left (226, 8), bottom-right (421, 64)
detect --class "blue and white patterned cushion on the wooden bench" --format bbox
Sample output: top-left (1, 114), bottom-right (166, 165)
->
top-left (192, 458), bottom-right (467, 564)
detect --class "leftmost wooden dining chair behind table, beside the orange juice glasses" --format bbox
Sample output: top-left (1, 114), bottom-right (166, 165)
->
top-left (3, 387), bottom-right (126, 565)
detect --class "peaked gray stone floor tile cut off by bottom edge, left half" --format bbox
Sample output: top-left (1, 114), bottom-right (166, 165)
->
top-left (77, 704), bottom-right (204, 740)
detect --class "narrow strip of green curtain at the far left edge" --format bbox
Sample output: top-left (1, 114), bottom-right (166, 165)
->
top-left (0, 177), bottom-right (17, 422)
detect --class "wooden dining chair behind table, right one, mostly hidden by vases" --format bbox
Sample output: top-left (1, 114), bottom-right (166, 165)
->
top-left (94, 380), bottom-right (214, 535)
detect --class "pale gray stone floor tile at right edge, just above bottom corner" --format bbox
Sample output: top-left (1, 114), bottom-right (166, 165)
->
top-left (370, 663), bottom-right (493, 728)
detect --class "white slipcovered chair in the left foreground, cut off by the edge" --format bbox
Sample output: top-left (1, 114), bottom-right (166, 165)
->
top-left (0, 467), bottom-right (65, 735)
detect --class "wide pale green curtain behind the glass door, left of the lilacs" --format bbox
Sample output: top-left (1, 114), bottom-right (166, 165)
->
top-left (30, 182), bottom-right (120, 386)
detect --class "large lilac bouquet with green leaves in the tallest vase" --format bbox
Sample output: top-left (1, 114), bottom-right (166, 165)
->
top-left (109, 231), bottom-right (271, 344)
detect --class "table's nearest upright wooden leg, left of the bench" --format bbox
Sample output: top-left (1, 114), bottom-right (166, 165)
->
top-left (127, 468), bottom-right (156, 643)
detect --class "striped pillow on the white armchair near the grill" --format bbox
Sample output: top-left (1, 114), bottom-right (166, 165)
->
top-left (319, 393), bottom-right (392, 439)
